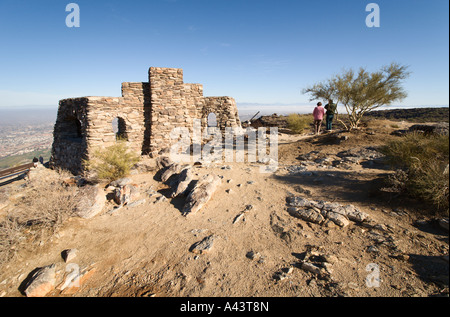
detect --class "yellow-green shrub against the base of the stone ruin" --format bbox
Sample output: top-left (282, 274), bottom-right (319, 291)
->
top-left (84, 140), bottom-right (140, 182)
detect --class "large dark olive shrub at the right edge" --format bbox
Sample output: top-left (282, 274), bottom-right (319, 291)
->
top-left (381, 133), bottom-right (449, 214)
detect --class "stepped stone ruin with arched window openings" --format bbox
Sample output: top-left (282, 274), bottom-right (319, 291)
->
top-left (50, 67), bottom-right (241, 174)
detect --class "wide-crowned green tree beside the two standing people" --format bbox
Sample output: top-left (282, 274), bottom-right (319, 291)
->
top-left (302, 63), bottom-right (410, 130)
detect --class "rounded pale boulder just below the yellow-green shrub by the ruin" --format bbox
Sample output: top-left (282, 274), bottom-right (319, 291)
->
top-left (75, 185), bottom-right (106, 219)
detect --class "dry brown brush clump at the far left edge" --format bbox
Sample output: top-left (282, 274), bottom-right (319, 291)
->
top-left (0, 171), bottom-right (77, 265)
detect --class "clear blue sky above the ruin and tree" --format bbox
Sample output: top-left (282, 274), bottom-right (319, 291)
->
top-left (0, 0), bottom-right (449, 113)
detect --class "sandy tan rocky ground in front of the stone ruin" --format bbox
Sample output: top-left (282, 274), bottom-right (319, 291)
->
top-left (0, 121), bottom-right (449, 297)
